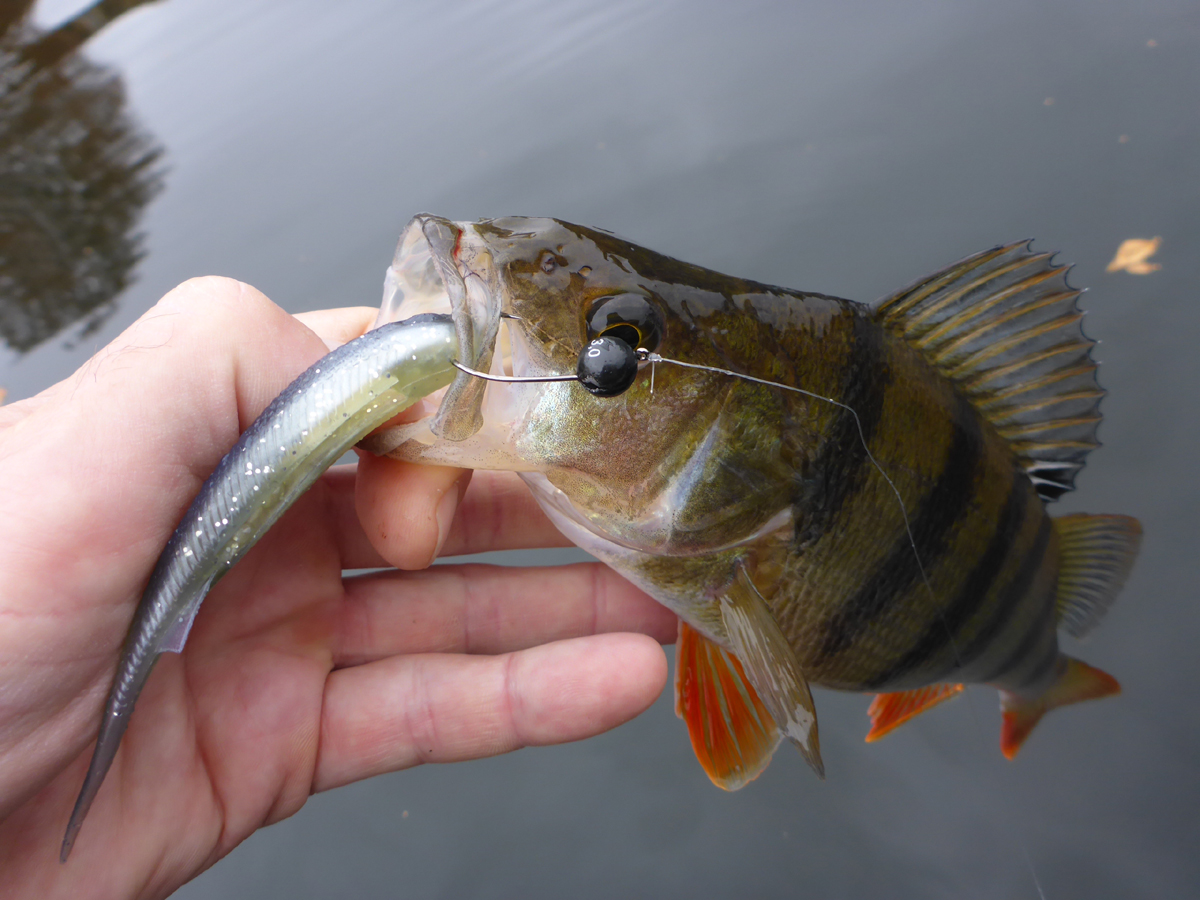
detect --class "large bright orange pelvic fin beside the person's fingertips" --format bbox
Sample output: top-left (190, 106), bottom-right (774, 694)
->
top-left (676, 620), bottom-right (781, 791)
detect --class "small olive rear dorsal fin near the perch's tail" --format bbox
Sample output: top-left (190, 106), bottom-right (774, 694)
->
top-left (1054, 512), bottom-right (1141, 637)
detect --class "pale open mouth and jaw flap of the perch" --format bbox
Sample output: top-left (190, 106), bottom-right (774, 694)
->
top-left (373, 214), bottom-right (503, 442)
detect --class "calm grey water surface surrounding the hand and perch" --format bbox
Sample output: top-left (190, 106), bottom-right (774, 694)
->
top-left (0, 0), bottom-right (1200, 900)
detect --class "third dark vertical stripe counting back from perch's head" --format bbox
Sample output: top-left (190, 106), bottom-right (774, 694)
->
top-left (868, 469), bottom-right (1030, 688)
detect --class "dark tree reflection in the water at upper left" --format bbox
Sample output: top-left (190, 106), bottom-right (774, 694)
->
top-left (0, 0), bottom-right (162, 352)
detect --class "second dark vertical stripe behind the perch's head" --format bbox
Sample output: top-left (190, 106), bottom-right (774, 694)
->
top-left (810, 395), bottom-right (983, 668)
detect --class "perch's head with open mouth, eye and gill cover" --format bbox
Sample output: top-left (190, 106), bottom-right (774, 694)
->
top-left (366, 216), bottom-right (816, 556)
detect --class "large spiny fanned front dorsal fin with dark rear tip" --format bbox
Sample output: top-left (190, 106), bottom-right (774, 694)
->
top-left (875, 241), bottom-right (1104, 500)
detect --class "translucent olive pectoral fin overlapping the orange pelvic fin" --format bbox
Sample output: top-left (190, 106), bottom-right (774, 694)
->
top-left (720, 565), bottom-right (824, 778)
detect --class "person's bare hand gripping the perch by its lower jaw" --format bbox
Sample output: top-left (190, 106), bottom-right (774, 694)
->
top-left (0, 278), bottom-right (676, 898)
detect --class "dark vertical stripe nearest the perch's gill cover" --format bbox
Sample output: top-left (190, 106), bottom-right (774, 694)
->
top-left (793, 314), bottom-right (892, 546)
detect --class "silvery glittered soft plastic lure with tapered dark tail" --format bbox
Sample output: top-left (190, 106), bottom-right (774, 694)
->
top-left (60, 313), bottom-right (458, 862)
